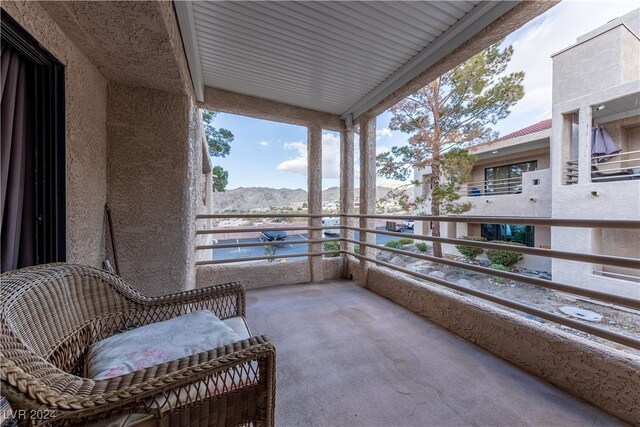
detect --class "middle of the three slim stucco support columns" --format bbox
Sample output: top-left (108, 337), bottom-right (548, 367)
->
top-left (340, 125), bottom-right (354, 278)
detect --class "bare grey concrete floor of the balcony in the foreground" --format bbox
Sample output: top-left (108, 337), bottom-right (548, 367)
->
top-left (247, 281), bottom-right (624, 426)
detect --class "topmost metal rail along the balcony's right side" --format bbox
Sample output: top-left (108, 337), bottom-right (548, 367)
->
top-left (342, 214), bottom-right (640, 230)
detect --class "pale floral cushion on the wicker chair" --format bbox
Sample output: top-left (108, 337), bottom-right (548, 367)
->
top-left (87, 310), bottom-right (241, 380)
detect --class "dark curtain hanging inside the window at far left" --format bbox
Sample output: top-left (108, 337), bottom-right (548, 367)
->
top-left (0, 42), bottom-right (34, 272)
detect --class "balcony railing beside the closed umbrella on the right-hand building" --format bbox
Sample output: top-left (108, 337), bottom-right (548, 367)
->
top-left (565, 150), bottom-right (640, 184)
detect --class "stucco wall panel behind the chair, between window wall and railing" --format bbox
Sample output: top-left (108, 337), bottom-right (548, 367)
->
top-left (107, 83), bottom-right (202, 295)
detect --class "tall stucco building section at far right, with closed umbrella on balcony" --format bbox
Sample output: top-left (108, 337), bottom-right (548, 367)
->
top-left (551, 9), bottom-right (640, 297)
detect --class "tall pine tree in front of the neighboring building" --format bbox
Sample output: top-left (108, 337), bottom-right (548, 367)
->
top-left (377, 43), bottom-right (524, 257)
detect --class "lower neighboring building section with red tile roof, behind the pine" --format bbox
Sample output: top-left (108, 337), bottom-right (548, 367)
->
top-left (415, 120), bottom-right (551, 272)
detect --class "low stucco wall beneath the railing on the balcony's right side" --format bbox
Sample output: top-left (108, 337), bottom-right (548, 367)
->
top-left (366, 267), bottom-right (640, 425)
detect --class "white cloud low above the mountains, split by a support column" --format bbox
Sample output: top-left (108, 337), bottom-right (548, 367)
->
top-left (276, 132), bottom-right (340, 179)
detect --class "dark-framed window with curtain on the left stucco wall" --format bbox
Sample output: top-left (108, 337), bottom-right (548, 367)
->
top-left (1, 10), bottom-right (66, 271)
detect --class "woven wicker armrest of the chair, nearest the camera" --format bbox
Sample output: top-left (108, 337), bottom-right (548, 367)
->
top-left (0, 336), bottom-right (275, 423)
